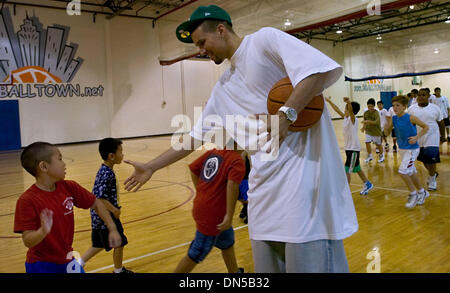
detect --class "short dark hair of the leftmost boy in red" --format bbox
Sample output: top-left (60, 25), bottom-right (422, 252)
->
top-left (20, 141), bottom-right (55, 177)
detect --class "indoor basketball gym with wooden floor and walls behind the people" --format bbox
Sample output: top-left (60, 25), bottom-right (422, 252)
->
top-left (0, 0), bottom-right (450, 273)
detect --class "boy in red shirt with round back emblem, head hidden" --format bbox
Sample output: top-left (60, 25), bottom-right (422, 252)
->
top-left (175, 149), bottom-right (245, 273)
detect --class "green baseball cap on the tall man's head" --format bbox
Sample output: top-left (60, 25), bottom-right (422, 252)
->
top-left (176, 5), bottom-right (232, 43)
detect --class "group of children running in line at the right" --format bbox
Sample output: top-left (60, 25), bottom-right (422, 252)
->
top-left (326, 88), bottom-right (450, 208)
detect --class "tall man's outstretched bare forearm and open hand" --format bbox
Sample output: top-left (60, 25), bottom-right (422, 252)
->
top-left (124, 136), bottom-right (202, 192)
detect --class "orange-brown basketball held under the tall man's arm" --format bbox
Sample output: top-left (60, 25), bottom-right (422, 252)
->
top-left (267, 77), bottom-right (324, 131)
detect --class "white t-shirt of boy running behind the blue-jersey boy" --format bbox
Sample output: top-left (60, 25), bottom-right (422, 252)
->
top-left (407, 103), bottom-right (443, 147)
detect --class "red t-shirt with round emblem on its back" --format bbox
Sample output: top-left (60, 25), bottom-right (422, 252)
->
top-left (189, 149), bottom-right (245, 236)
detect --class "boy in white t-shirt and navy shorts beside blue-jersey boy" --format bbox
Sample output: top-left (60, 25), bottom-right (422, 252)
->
top-left (408, 89), bottom-right (442, 190)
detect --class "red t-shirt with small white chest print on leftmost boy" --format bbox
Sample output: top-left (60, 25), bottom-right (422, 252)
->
top-left (14, 181), bottom-right (95, 264)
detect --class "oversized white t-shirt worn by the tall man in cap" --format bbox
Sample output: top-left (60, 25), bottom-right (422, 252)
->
top-left (191, 28), bottom-right (358, 243)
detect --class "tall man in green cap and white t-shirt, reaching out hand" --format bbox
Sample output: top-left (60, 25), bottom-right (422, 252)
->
top-left (125, 5), bottom-right (358, 272)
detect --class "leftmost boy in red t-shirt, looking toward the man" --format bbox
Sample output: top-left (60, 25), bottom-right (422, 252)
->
top-left (14, 142), bottom-right (121, 273)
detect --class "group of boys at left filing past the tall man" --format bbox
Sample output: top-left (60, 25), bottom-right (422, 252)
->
top-left (14, 138), bottom-right (251, 273)
